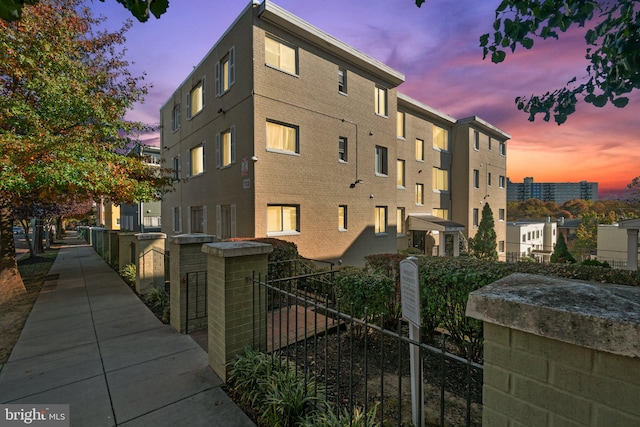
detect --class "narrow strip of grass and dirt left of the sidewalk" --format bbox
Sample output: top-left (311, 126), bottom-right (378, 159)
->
top-left (0, 249), bottom-right (59, 364)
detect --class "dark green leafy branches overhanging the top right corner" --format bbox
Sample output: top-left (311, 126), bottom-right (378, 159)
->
top-left (416, 0), bottom-right (640, 125)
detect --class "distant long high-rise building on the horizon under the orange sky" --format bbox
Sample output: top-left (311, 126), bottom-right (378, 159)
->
top-left (507, 177), bottom-right (598, 205)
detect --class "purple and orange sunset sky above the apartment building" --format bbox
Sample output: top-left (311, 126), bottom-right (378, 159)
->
top-left (90, 0), bottom-right (640, 196)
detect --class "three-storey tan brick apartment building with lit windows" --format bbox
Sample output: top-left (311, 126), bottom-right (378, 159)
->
top-left (161, 0), bottom-right (510, 264)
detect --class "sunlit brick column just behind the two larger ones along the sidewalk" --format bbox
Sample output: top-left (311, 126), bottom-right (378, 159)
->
top-left (135, 233), bottom-right (167, 295)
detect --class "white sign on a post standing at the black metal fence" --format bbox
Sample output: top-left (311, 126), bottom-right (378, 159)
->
top-left (400, 257), bottom-right (424, 427)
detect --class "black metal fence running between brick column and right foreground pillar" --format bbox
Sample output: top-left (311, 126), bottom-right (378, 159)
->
top-left (252, 271), bottom-right (483, 426)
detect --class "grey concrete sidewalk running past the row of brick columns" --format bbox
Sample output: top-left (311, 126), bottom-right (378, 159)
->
top-left (0, 239), bottom-right (255, 427)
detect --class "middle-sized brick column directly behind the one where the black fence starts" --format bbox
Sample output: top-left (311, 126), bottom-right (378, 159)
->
top-left (169, 234), bottom-right (216, 333)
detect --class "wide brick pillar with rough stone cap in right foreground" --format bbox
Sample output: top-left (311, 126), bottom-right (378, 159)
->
top-left (467, 274), bottom-right (640, 426)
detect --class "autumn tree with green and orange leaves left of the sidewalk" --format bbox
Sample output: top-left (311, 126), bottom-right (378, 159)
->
top-left (0, 0), bottom-right (170, 302)
